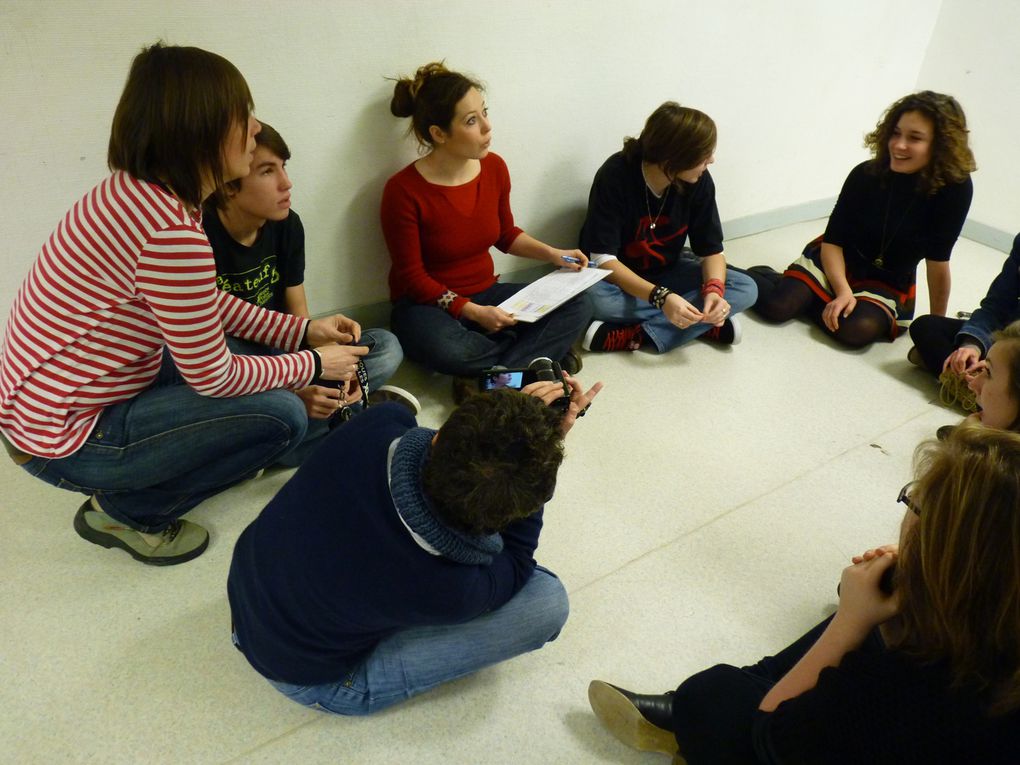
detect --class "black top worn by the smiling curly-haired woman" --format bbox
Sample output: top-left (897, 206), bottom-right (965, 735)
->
top-left (824, 160), bottom-right (974, 290)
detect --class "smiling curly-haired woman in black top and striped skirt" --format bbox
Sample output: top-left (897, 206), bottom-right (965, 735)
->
top-left (748, 91), bottom-right (976, 348)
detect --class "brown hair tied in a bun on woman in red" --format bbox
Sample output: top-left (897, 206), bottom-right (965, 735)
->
top-left (390, 61), bottom-right (485, 149)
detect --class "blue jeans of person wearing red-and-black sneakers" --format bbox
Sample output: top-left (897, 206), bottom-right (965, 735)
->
top-left (588, 258), bottom-right (758, 353)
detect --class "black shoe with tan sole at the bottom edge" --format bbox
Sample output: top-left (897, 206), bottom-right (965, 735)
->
top-left (588, 680), bottom-right (677, 755)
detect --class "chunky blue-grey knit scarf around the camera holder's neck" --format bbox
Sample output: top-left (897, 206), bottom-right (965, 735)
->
top-left (390, 427), bottom-right (503, 565)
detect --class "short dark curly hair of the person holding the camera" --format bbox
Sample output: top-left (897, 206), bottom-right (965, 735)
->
top-left (421, 389), bottom-right (563, 533)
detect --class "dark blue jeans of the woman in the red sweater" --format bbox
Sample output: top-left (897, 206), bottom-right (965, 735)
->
top-left (390, 283), bottom-right (592, 376)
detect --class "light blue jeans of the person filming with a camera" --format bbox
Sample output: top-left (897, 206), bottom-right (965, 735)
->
top-left (269, 566), bottom-right (569, 715)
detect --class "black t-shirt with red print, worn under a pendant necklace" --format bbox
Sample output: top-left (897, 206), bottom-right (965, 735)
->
top-left (580, 152), bottom-right (722, 279)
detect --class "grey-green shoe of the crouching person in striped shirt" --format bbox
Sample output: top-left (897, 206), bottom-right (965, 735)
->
top-left (74, 500), bottom-right (209, 566)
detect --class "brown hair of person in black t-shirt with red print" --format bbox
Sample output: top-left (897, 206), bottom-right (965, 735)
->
top-left (623, 101), bottom-right (717, 177)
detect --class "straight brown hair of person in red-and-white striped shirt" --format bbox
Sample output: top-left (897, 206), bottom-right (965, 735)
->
top-left (107, 42), bottom-right (254, 207)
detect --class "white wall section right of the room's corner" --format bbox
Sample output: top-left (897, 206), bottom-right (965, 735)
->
top-left (918, 0), bottom-right (1020, 242)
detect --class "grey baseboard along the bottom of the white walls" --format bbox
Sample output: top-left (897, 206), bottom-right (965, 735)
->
top-left (324, 197), bottom-right (1015, 327)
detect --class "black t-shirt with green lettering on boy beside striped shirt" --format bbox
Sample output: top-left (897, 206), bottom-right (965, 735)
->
top-left (202, 210), bottom-right (305, 311)
